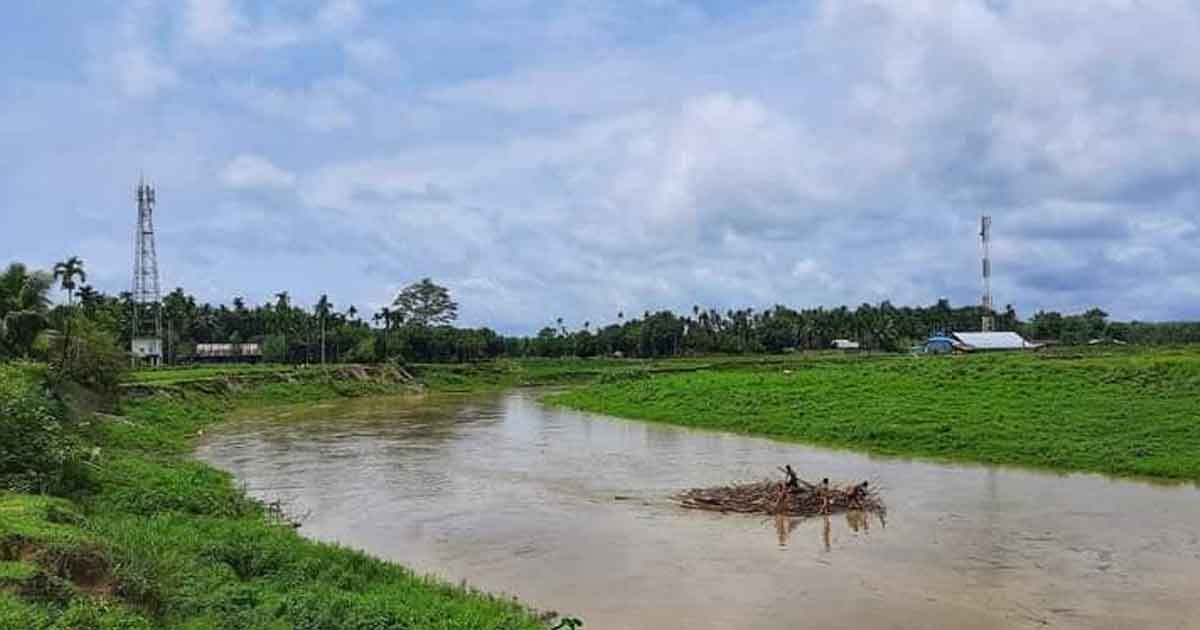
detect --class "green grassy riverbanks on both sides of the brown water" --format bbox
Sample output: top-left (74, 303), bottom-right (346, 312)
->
top-left (0, 349), bottom-right (1200, 629)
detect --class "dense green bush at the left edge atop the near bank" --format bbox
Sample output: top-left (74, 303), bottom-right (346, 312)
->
top-left (0, 364), bottom-right (86, 494)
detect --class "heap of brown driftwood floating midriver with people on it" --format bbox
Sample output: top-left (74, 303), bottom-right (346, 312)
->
top-left (676, 466), bottom-right (883, 516)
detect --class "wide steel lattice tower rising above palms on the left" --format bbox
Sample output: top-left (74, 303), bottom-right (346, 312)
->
top-left (130, 175), bottom-right (162, 366)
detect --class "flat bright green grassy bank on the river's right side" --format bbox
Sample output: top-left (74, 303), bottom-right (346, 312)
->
top-left (550, 348), bottom-right (1200, 480)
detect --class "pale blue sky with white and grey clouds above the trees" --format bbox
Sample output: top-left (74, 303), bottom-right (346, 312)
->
top-left (0, 0), bottom-right (1200, 332)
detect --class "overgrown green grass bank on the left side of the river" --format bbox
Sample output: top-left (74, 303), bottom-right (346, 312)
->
top-left (0, 365), bottom-right (544, 630)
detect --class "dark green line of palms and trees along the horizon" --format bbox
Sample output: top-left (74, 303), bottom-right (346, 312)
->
top-left (0, 257), bottom-right (1200, 365)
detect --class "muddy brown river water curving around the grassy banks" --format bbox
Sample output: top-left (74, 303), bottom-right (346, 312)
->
top-left (198, 391), bottom-right (1200, 629)
